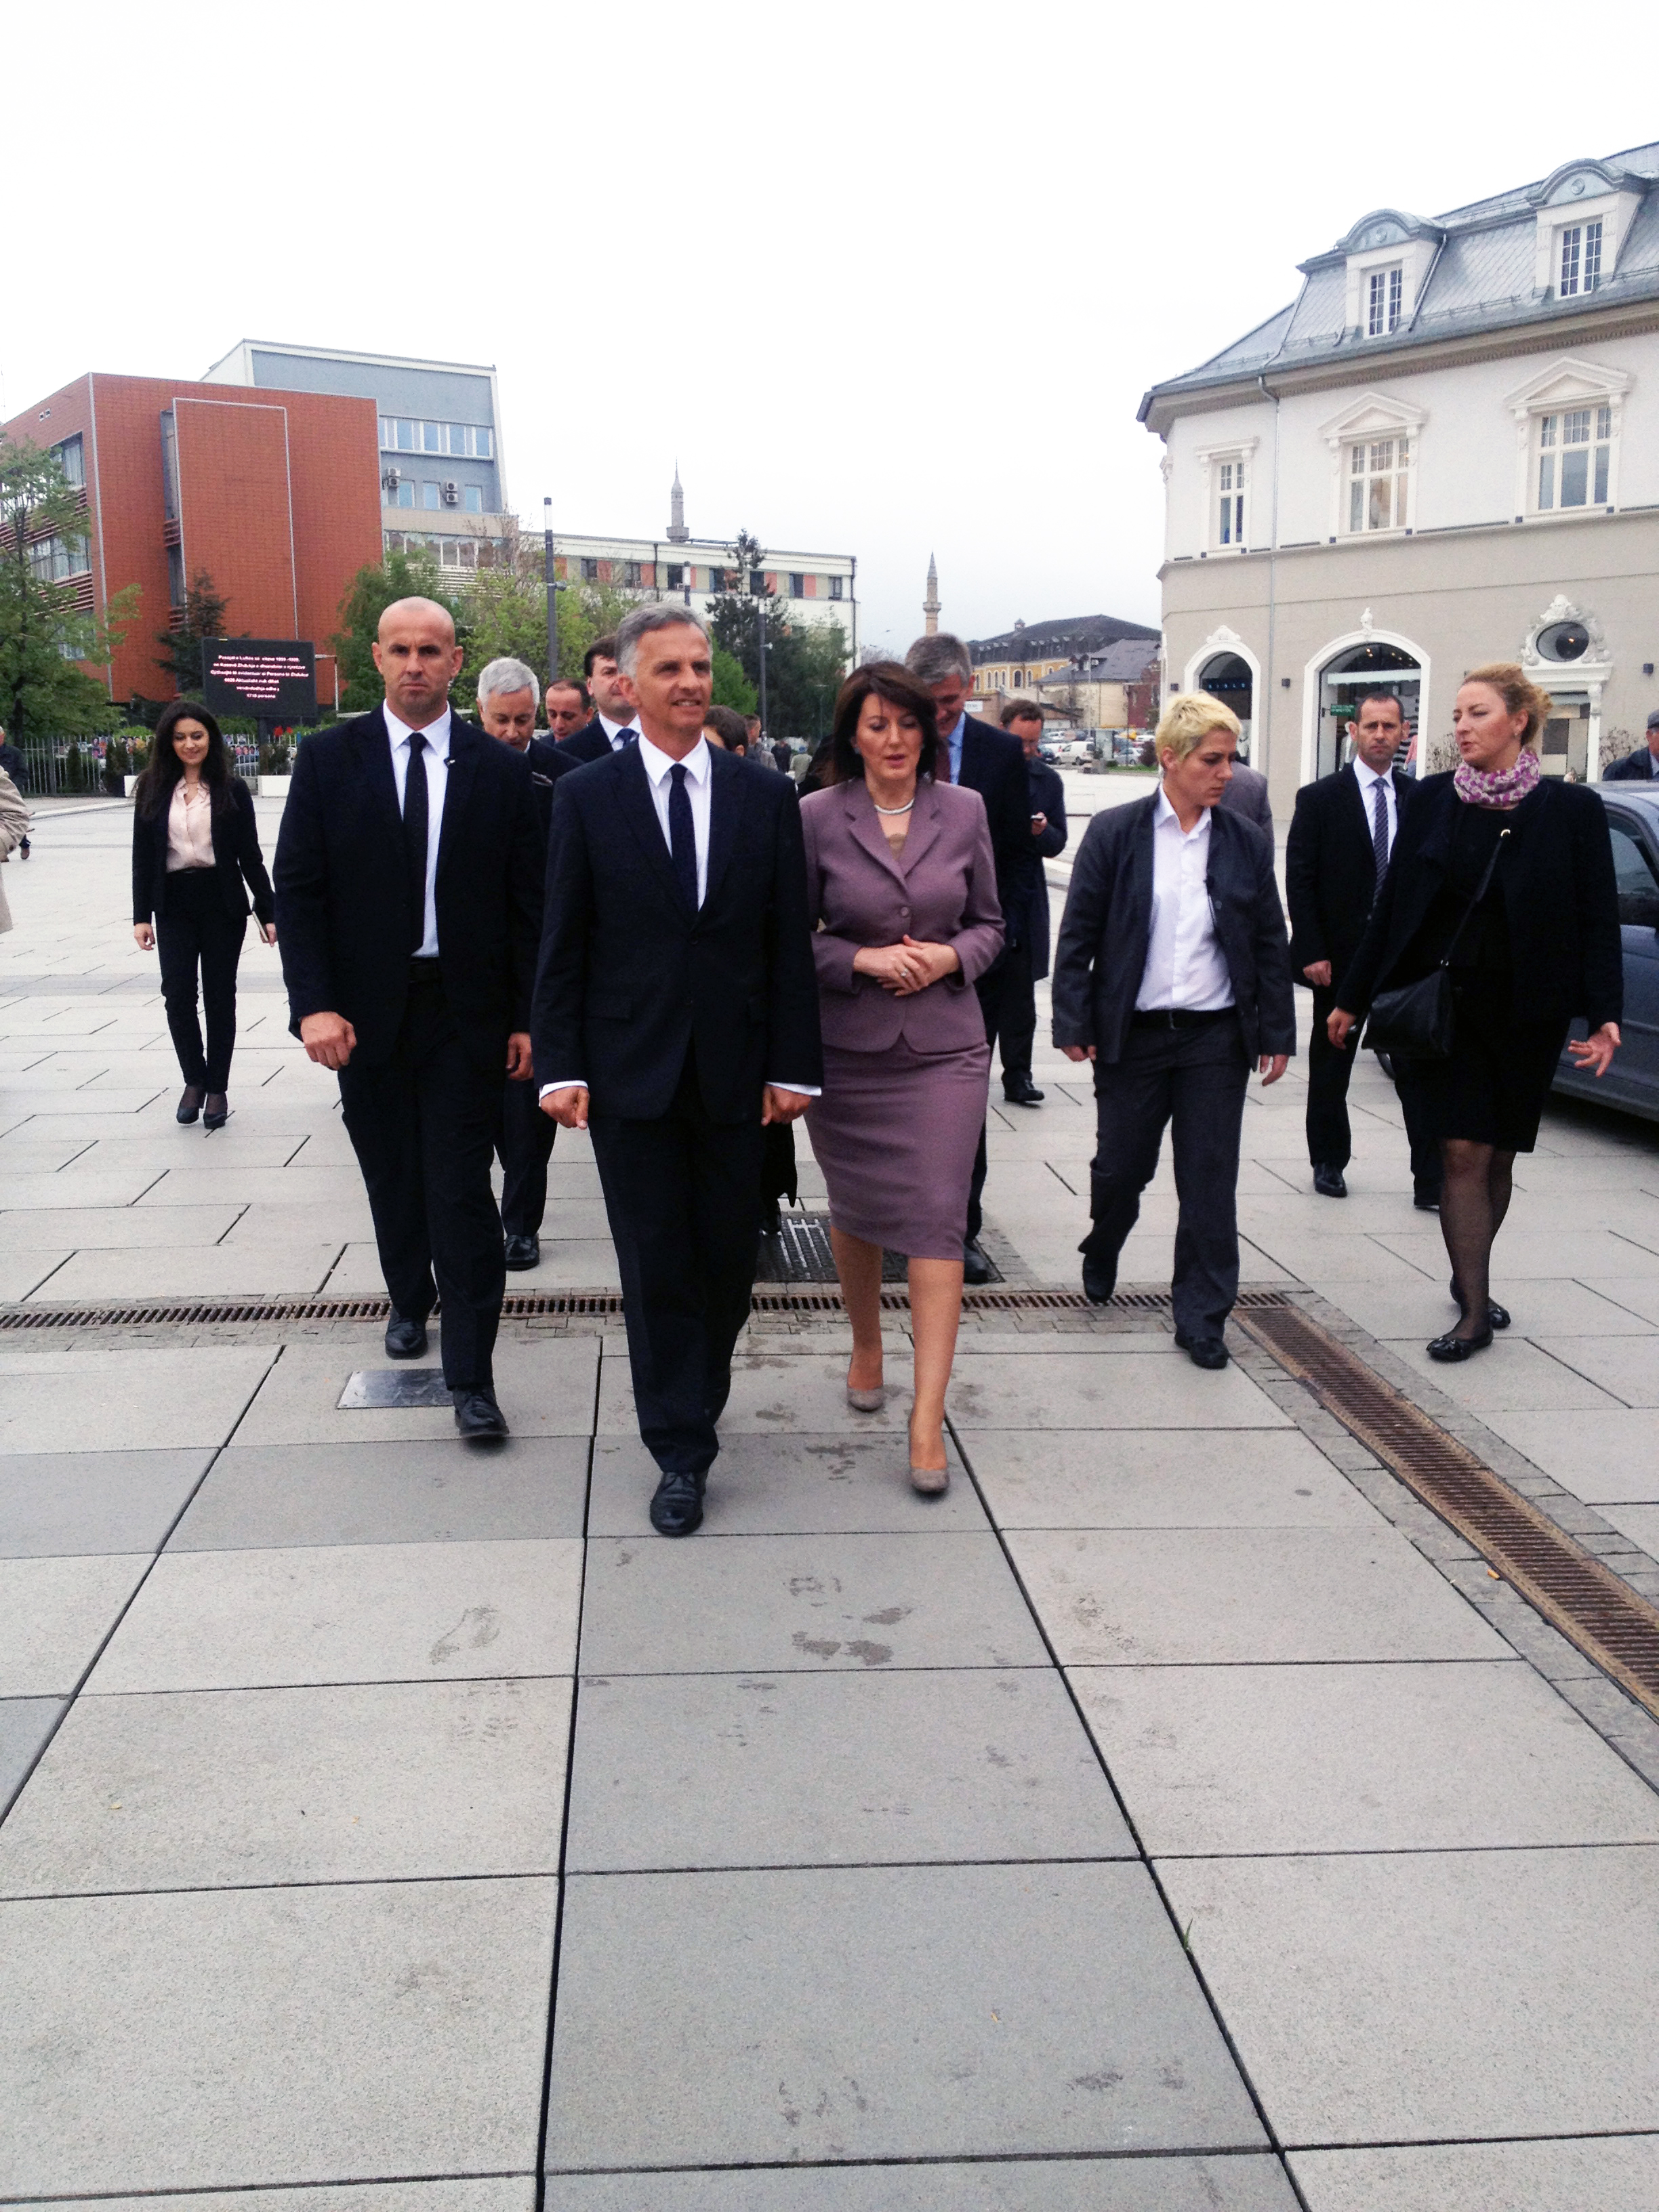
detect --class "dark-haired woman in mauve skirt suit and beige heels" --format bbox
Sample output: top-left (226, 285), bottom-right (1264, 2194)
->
top-left (801, 661), bottom-right (1002, 1495)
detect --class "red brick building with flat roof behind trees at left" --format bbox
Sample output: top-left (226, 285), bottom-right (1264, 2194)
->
top-left (0, 374), bottom-right (380, 705)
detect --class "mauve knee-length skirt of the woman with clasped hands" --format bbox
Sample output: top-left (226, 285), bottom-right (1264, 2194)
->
top-left (807, 1038), bottom-right (991, 1258)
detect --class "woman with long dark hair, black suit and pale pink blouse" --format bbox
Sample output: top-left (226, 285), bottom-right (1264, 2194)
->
top-left (133, 699), bottom-right (276, 1130)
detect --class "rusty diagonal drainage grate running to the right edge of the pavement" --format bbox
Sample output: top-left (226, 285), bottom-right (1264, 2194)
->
top-left (1243, 1307), bottom-right (1659, 1717)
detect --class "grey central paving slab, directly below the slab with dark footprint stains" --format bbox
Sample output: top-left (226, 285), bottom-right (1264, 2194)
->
top-left (562, 1668), bottom-right (1132, 1874)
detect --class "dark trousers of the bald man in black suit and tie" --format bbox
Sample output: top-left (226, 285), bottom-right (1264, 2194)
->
top-left (341, 962), bottom-right (506, 1389)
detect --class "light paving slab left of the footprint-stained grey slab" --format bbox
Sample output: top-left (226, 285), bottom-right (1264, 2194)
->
top-left (90, 1540), bottom-right (581, 1696)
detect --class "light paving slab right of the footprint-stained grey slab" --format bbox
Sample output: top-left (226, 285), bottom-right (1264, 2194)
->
top-left (1008, 1524), bottom-right (1504, 1666)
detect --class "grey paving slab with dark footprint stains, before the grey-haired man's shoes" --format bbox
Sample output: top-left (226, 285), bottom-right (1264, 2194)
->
top-left (581, 1535), bottom-right (1046, 1675)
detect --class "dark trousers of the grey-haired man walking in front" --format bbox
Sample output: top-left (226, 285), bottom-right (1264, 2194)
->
top-left (588, 1055), bottom-right (761, 1475)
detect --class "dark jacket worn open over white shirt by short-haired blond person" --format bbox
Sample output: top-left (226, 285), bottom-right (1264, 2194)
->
top-left (1053, 792), bottom-right (1296, 1066)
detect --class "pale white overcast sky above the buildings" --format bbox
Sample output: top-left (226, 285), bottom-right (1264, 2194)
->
top-left (13, 0), bottom-right (1659, 651)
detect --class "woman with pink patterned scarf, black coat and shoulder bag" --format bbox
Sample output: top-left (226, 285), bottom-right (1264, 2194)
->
top-left (1327, 661), bottom-right (1624, 1360)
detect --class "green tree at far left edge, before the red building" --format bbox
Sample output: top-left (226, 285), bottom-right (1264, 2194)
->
top-left (0, 441), bottom-right (137, 745)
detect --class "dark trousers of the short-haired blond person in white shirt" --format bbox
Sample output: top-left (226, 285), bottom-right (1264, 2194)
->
top-left (1082, 1015), bottom-right (1250, 1336)
